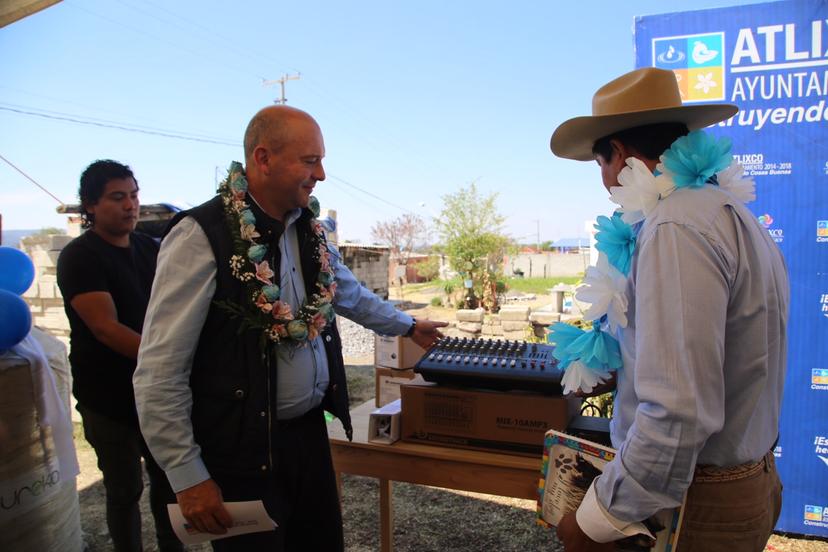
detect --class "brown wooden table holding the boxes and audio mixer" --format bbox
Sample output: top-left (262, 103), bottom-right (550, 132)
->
top-left (328, 400), bottom-right (541, 552)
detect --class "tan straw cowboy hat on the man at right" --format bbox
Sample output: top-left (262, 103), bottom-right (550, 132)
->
top-left (550, 67), bottom-right (739, 161)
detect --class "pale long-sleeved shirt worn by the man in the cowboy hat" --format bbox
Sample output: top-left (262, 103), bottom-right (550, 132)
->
top-left (577, 185), bottom-right (789, 542)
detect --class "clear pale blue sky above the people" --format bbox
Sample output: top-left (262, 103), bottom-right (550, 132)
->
top-left (0, 0), bottom-right (764, 243)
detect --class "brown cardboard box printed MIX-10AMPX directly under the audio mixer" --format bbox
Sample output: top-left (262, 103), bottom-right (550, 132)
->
top-left (400, 383), bottom-right (581, 455)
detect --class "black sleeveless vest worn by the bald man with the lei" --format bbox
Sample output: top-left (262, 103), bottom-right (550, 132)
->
top-left (167, 196), bottom-right (353, 476)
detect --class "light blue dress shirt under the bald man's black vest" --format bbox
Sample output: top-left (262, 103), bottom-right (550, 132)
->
top-left (133, 210), bottom-right (413, 492)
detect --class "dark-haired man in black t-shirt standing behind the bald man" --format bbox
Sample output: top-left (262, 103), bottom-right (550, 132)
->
top-left (57, 160), bottom-right (183, 551)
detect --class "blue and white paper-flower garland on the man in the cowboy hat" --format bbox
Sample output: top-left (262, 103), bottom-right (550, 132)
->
top-left (548, 130), bottom-right (756, 393)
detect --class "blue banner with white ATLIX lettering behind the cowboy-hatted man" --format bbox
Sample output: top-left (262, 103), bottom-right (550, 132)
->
top-left (635, 0), bottom-right (828, 536)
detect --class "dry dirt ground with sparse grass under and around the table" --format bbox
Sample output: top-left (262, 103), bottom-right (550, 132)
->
top-left (76, 289), bottom-right (828, 552)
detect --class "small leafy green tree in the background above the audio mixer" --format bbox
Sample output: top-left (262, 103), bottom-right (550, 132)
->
top-left (435, 183), bottom-right (509, 306)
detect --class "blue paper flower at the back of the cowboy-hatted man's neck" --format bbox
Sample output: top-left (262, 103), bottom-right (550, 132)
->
top-left (660, 130), bottom-right (733, 188)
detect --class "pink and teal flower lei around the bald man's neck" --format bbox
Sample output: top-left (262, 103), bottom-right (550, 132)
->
top-left (216, 161), bottom-right (336, 346)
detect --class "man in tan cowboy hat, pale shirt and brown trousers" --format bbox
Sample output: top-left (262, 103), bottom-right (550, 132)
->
top-left (551, 68), bottom-right (789, 552)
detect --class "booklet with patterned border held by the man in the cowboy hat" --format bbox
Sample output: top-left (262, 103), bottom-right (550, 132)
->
top-left (537, 430), bottom-right (684, 552)
